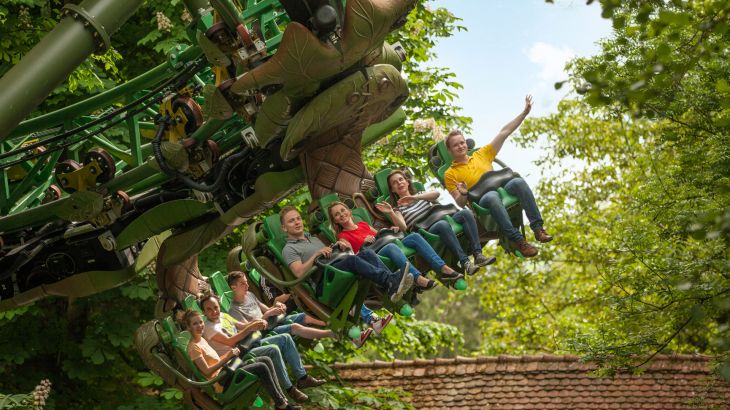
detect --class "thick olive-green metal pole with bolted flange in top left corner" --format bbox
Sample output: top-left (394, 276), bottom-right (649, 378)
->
top-left (0, 0), bottom-right (142, 141)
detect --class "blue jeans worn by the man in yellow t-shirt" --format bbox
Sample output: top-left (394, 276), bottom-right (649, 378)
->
top-left (479, 178), bottom-right (543, 242)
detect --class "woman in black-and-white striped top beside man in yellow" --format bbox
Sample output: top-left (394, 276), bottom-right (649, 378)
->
top-left (388, 170), bottom-right (496, 275)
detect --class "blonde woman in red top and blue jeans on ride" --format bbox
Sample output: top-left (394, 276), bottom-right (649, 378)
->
top-left (328, 202), bottom-right (463, 289)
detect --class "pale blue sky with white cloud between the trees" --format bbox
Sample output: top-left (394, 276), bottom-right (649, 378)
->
top-left (430, 0), bottom-right (611, 187)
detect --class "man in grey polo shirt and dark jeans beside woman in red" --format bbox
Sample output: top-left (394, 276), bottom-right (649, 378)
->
top-left (279, 206), bottom-right (413, 302)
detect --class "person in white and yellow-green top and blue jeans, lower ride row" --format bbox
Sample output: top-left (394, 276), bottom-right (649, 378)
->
top-left (200, 294), bottom-right (325, 402)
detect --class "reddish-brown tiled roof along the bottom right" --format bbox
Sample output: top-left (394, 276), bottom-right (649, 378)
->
top-left (335, 355), bottom-right (730, 410)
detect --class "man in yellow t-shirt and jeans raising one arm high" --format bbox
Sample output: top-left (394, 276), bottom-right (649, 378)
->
top-left (444, 95), bottom-right (553, 257)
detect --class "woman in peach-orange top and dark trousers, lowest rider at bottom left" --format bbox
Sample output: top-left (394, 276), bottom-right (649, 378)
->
top-left (180, 309), bottom-right (301, 410)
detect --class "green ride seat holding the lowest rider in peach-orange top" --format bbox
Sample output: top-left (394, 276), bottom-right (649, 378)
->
top-left (161, 316), bottom-right (259, 409)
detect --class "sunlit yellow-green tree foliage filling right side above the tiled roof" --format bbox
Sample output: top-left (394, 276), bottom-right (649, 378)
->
top-left (440, 0), bottom-right (730, 377)
